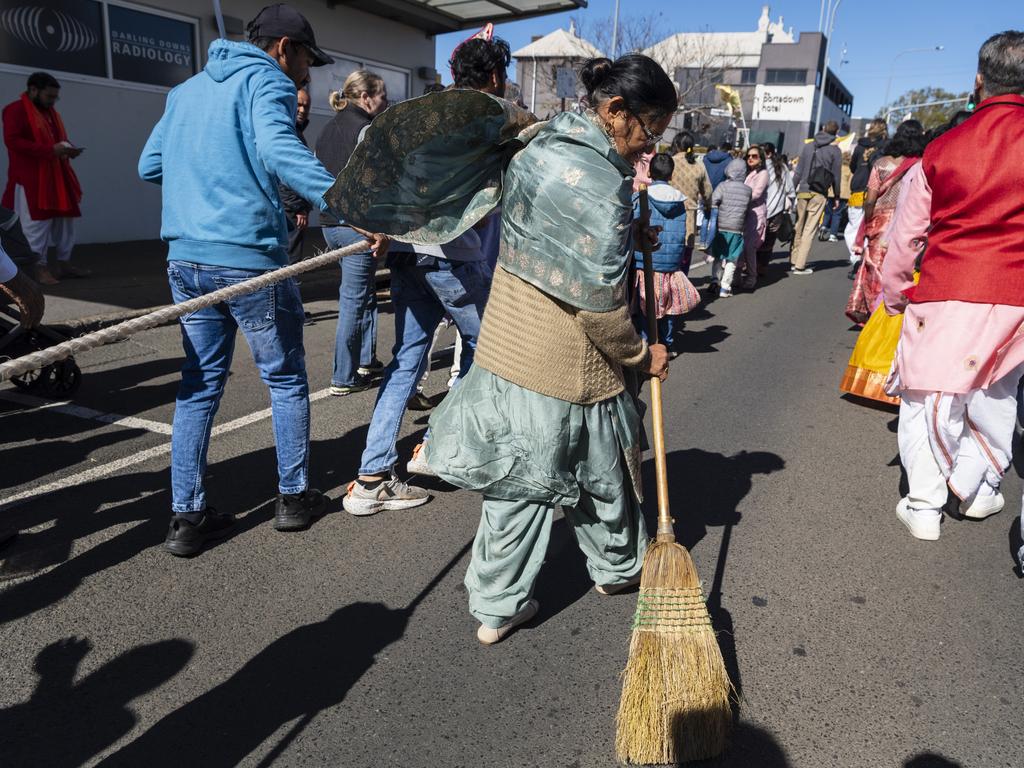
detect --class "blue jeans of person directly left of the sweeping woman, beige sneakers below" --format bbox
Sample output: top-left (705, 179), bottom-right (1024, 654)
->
top-left (359, 254), bottom-right (492, 475)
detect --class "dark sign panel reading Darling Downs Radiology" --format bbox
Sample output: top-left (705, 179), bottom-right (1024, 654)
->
top-left (106, 5), bottom-right (196, 88)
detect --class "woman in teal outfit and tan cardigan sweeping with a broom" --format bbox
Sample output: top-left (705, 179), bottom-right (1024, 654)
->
top-left (429, 55), bottom-right (677, 644)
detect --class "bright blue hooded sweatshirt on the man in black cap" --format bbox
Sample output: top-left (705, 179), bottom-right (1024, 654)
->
top-left (138, 40), bottom-right (334, 269)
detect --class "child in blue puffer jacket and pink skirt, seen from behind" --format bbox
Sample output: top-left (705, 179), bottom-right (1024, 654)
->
top-left (633, 153), bottom-right (700, 357)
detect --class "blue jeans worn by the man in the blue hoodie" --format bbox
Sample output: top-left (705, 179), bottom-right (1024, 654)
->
top-left (167, 261), bottom-right (309, 513)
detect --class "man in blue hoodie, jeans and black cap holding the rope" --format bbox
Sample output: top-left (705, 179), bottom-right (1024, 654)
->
top-left (138, 5), bottom-right (344, 556)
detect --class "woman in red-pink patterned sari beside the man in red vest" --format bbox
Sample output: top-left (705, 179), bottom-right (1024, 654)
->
top-left (846, 120), bottom-right (928, 326)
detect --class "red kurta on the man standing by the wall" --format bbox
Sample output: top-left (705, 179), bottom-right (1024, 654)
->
top-left (0, 98), bottom-right (82, 221)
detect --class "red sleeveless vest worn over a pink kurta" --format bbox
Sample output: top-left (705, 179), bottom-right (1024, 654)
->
top-left (911, 95), bottom-right (1024, 306)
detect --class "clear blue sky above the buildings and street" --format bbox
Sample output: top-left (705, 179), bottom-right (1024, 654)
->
top-left (436, 0), bottom-right (1024, 116)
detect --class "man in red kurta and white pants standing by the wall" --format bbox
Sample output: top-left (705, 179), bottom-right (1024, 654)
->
top-left (2, 72), bottom-right (88, 286)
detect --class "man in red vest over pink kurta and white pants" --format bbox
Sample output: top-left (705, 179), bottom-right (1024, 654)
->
top-left (882, 32), bottom-right (1024, 541)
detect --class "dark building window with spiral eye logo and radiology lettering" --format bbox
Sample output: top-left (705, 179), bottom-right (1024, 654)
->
top-left (0, 0), bottom-right (199, 88)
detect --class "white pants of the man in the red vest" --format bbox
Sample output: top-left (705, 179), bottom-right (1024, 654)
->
top-left (898, 366), bottom-right (1024, 511)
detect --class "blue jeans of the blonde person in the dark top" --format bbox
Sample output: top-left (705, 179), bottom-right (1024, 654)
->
top-left (323, 226), bottom-right (377, 387)
